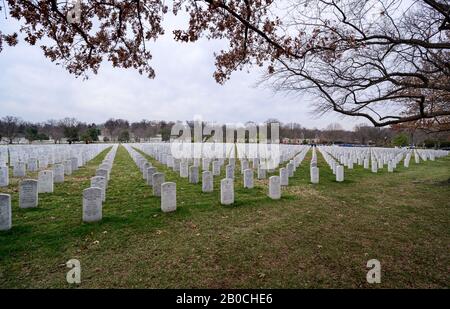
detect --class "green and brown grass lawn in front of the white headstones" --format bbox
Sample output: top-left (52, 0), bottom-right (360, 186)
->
top-left (0, 146), bottom-right (450, 288)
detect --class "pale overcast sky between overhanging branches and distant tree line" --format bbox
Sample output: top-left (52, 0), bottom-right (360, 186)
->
top-left (0, 10), bottom-right (363, 129)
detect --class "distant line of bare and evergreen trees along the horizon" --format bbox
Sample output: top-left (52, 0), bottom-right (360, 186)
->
top-left (0, 116), bottom-right (450, 148)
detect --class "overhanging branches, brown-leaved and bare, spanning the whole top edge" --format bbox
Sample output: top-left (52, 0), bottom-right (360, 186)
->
top-left (0, 0), bottom-right (450, 130)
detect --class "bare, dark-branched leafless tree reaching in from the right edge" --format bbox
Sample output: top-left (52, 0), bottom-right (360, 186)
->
top-left (268, 0), bottom-right (450, 126)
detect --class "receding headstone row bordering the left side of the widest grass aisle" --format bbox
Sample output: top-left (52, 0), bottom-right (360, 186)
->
top-left (83, 145), bottom-right (118, 223)
